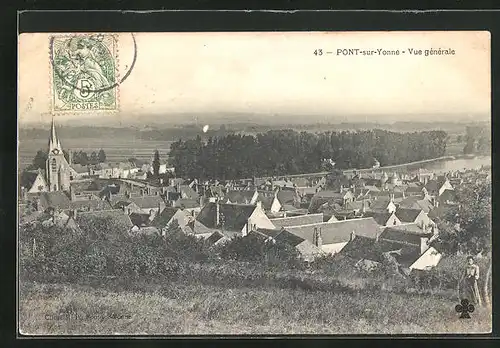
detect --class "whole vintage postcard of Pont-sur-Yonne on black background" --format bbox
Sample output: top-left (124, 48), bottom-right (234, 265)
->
top-left (17, 31), bottom-right (492, 337)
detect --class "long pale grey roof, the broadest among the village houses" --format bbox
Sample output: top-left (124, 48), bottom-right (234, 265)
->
top-left (287, 218), bottom-right (380, 245)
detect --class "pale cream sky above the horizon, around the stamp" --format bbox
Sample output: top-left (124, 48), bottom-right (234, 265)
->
top-left (18, 31), bottom-right (491, 124)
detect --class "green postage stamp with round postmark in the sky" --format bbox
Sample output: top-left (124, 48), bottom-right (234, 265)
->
top-left (50, 33), bottom-right (119, 112)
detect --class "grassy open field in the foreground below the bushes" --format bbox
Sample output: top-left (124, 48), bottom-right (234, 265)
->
top-left (19, 282), bottom-right (491, 335)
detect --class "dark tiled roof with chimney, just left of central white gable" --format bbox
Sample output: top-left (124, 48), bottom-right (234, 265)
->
top-left (196, 202), bottom-right (256, 232)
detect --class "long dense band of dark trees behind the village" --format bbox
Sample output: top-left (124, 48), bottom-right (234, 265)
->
top-left (169, 129), bottom-right (448, 180)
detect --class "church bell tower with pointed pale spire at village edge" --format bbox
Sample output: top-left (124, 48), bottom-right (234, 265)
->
top-left (45, 118), bottom-right (70, 191)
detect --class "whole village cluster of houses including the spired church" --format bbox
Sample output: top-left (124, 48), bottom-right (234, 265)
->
top-left (19, 119), bottom-right (489, 270)
